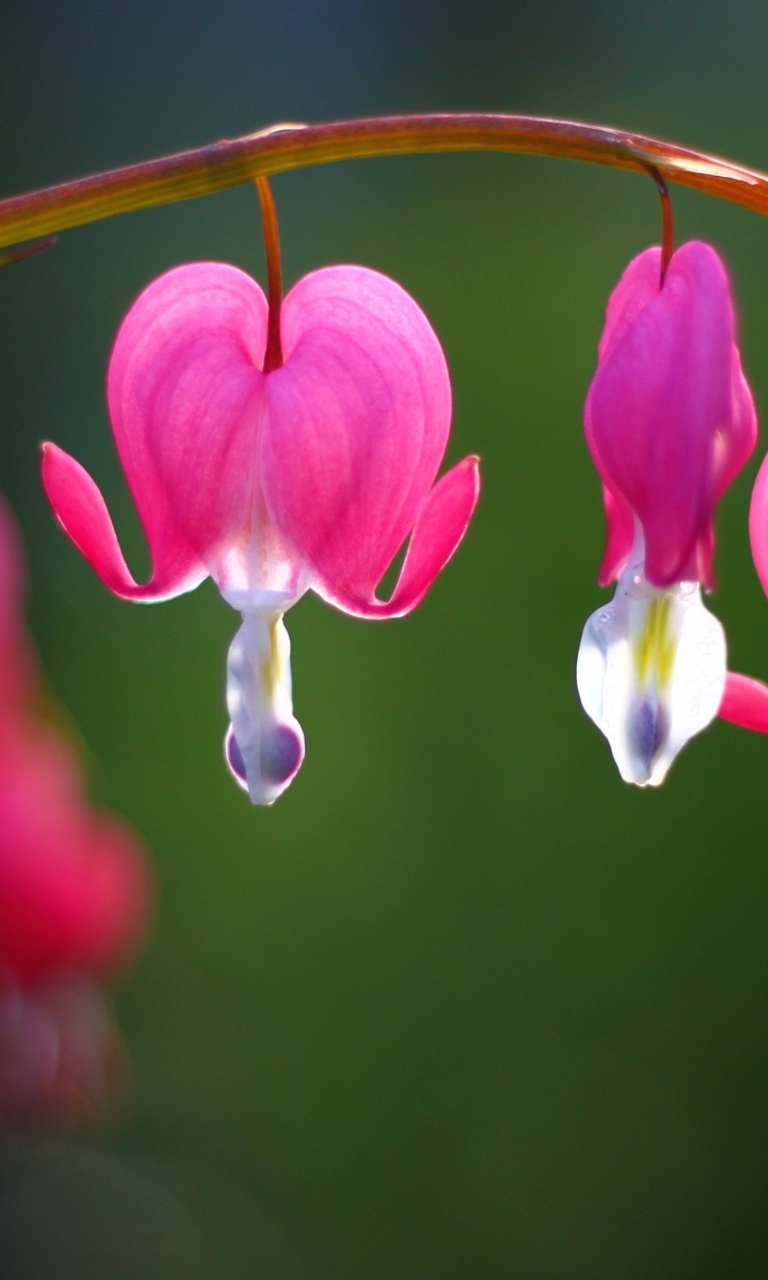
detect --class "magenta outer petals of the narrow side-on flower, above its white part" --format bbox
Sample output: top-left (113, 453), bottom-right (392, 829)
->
top-left (585, 241), bottom-right (756, 588)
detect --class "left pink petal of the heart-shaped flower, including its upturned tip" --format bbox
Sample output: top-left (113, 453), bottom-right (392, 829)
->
top-left (45, 262), bottom-right (272, 599)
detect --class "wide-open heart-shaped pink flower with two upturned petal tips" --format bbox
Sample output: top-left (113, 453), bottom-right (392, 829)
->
top-left (42, 262), bottom-right (479, 804)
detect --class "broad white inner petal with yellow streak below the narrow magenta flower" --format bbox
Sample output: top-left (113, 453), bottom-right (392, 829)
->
top-left (576, 566), bottom-right (726, 786)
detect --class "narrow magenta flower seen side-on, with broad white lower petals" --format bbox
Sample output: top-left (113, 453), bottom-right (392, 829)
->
top-left (576, 241), bottom-right (756, 786)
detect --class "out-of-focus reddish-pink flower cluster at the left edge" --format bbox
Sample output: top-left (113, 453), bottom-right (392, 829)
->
top-left (0, 504), bottom-right (151, 1125)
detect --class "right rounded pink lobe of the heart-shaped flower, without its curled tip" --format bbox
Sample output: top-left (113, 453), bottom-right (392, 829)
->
top-left (261, 266), bottom-right (451, 609)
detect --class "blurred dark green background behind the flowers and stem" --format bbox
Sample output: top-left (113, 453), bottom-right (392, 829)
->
top-left (0, 0), bottom-right (768, 1280)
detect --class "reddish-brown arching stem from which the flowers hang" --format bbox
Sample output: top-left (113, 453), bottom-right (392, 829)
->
top-left (0, 114), bottom-right (768, 248)
